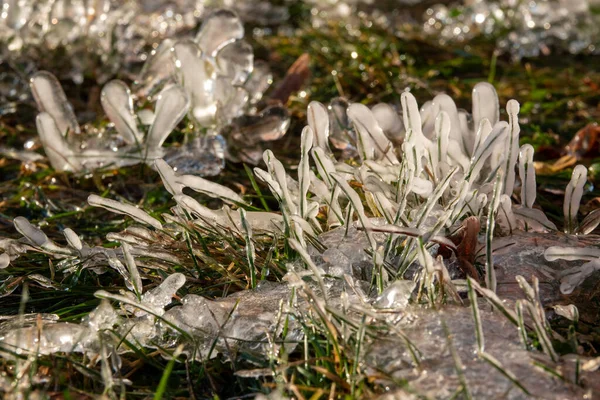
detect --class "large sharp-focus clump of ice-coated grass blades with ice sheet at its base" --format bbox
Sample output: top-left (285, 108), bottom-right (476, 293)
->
top-left (0, 83), bottom-right (600, 398)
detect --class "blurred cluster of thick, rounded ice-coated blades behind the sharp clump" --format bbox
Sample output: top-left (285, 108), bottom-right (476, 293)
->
top-left (30, 10), bottom-right (289, 175)
